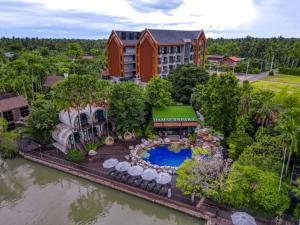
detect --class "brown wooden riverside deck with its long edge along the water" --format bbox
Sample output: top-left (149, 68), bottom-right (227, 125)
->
top-left (21, 142), bottom-right (269, 225)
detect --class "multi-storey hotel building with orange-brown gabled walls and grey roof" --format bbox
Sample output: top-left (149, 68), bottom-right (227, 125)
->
top-left (106, 29), bottom-right (206, 82)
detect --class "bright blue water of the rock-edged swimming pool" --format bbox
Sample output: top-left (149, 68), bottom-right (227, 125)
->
top-left (144, 146), bottom-right (192, 166)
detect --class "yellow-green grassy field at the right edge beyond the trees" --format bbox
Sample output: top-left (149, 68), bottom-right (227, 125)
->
top-left (253, 74), bottom-right (300, 97)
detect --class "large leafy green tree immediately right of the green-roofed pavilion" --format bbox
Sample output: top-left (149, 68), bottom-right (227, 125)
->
top-left (192, 73), bottom-right (241, 137)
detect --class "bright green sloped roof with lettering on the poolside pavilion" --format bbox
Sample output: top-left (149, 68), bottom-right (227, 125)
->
top-left (152, 105), bottom-right (199, 122)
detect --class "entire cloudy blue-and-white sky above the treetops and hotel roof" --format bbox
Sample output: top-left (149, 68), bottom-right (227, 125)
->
top-left (0, 0), bottom-right (300, 39)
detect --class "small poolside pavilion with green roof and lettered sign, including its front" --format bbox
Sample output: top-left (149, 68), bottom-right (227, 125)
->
top-left (152, 105), bottom-right (199, 136)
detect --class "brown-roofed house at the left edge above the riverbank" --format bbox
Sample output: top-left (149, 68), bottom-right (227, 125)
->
top-left (0, 93), bottom-right (29, 130)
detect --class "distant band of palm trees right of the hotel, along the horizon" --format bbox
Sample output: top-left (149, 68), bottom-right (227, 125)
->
top-left (207, 36), bottom-right (300, 68)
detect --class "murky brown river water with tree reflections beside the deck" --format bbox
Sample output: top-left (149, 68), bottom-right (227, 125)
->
top-left (0, 159), bottom-right (204, 225)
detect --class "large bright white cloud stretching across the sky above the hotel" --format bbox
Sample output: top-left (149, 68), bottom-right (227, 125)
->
top-left (27, 0), bottom-right (256, 29)
